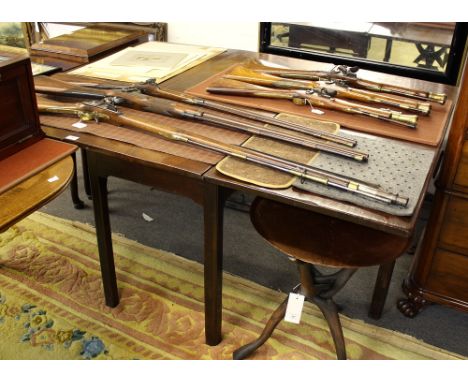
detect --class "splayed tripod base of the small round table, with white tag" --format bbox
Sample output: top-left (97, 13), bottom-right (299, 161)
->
top-left (233, 260), bottom-right (356, 360)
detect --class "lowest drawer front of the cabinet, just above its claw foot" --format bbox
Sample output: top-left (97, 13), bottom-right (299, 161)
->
top-left (427, 250), bottom-right (468, 303)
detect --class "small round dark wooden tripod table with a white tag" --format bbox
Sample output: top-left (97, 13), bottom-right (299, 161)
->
top-left (233, 198), bottom-right (411, 359)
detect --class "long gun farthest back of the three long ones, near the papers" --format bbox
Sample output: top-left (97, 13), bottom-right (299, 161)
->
top-left (47, 79), bottom-right (357, 147)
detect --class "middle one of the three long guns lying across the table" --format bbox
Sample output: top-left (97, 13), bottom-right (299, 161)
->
top-left (34, 76), bottom-right (369, 162)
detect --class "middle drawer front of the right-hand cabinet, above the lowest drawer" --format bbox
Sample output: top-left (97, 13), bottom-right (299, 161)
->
top-left (438, 195), bottom-right (468, 256)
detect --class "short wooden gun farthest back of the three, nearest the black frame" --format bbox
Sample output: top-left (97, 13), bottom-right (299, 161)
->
top-left (245, 61), bottom-right (447, 105)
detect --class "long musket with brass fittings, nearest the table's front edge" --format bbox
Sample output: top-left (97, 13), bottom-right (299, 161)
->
top-left (37, 97), bottom-right (408, 206)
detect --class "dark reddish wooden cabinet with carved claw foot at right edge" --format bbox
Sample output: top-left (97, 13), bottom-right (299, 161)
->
top-left (398, 60), bottom-right (468, 317)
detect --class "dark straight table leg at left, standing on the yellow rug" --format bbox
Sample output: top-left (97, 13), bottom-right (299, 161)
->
top-left (88, 153), bottom-right (119, 307)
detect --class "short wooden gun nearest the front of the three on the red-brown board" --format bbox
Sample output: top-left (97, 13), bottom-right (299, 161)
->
top-left (206, 79), bottom-right (418, 129)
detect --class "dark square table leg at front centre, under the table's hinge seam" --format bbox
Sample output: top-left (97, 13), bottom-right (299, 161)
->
top-left (203, 183), bottom-right (226, 346)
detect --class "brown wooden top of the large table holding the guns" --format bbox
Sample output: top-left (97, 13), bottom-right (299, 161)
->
top-left (44, 51), bottom-right (456, 236)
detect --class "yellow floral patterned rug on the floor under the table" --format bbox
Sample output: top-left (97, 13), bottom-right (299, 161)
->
top-left (0, 213), bottom-right (461, 360)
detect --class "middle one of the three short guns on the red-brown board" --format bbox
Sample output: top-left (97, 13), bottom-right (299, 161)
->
top-left (223, 65), bottom-right (431, 115)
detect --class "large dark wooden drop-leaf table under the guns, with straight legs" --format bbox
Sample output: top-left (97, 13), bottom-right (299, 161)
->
top-left (41, 51), bottom-right (455, 345)
